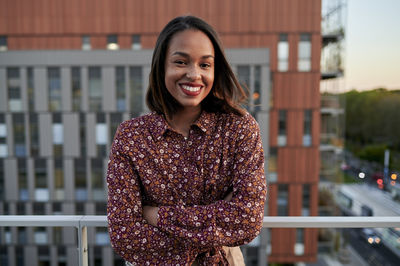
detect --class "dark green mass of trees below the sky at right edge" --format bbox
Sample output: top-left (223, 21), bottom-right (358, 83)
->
top-left (340, 89), bottom-right (400, 168)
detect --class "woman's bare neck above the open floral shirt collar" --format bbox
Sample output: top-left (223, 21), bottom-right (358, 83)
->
top-left (167, 108), bottom-right (201, 137)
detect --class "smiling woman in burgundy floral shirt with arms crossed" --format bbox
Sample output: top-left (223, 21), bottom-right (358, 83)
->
top-left (107, 16), bottom-right (266, 265)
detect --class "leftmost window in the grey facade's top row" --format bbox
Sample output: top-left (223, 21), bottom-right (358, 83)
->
top-left (7, 67), bottom-right (22, 112)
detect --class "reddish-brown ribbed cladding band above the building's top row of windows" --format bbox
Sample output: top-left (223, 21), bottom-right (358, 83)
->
top-left (0, 0), bottom-right (321, 35)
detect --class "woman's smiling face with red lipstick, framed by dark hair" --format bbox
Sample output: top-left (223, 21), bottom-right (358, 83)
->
top-left (165, 29), bottom-right (215, 114)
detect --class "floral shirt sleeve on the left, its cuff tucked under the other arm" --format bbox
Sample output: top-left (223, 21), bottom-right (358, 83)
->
top-left (107, 124), bottom-right (178, 261)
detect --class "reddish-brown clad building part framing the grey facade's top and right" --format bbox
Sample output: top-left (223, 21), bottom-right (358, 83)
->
top-left (0, 0), bottom-right (321, 262)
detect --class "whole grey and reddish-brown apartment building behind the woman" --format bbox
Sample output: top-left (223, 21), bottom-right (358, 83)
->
top-left (0, 0), bottom-right (321, 265)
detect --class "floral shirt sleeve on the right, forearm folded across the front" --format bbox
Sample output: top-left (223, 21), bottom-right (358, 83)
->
top-left (157, 115), bottom-right (267, 248)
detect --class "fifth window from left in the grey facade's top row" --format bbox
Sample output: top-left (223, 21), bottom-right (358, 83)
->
top-left (89, 67), bottom-right (103, 112)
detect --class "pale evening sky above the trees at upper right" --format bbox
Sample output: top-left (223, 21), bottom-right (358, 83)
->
top-left (346, 0), bottom-right (400, 90)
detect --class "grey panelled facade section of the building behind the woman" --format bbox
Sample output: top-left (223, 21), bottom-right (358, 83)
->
top-left (0, 48), bottom-right (270, 266)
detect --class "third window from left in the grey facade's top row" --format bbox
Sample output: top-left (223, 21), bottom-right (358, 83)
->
top-left (47, 67), bottom-right (61, 111)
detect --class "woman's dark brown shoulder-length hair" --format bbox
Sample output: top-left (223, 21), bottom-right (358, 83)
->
top-left (146, 16), bottom-right (247, 117)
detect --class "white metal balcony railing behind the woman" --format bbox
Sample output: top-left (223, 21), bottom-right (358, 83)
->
top-left (0, 215), bottom-right (400, 266)
